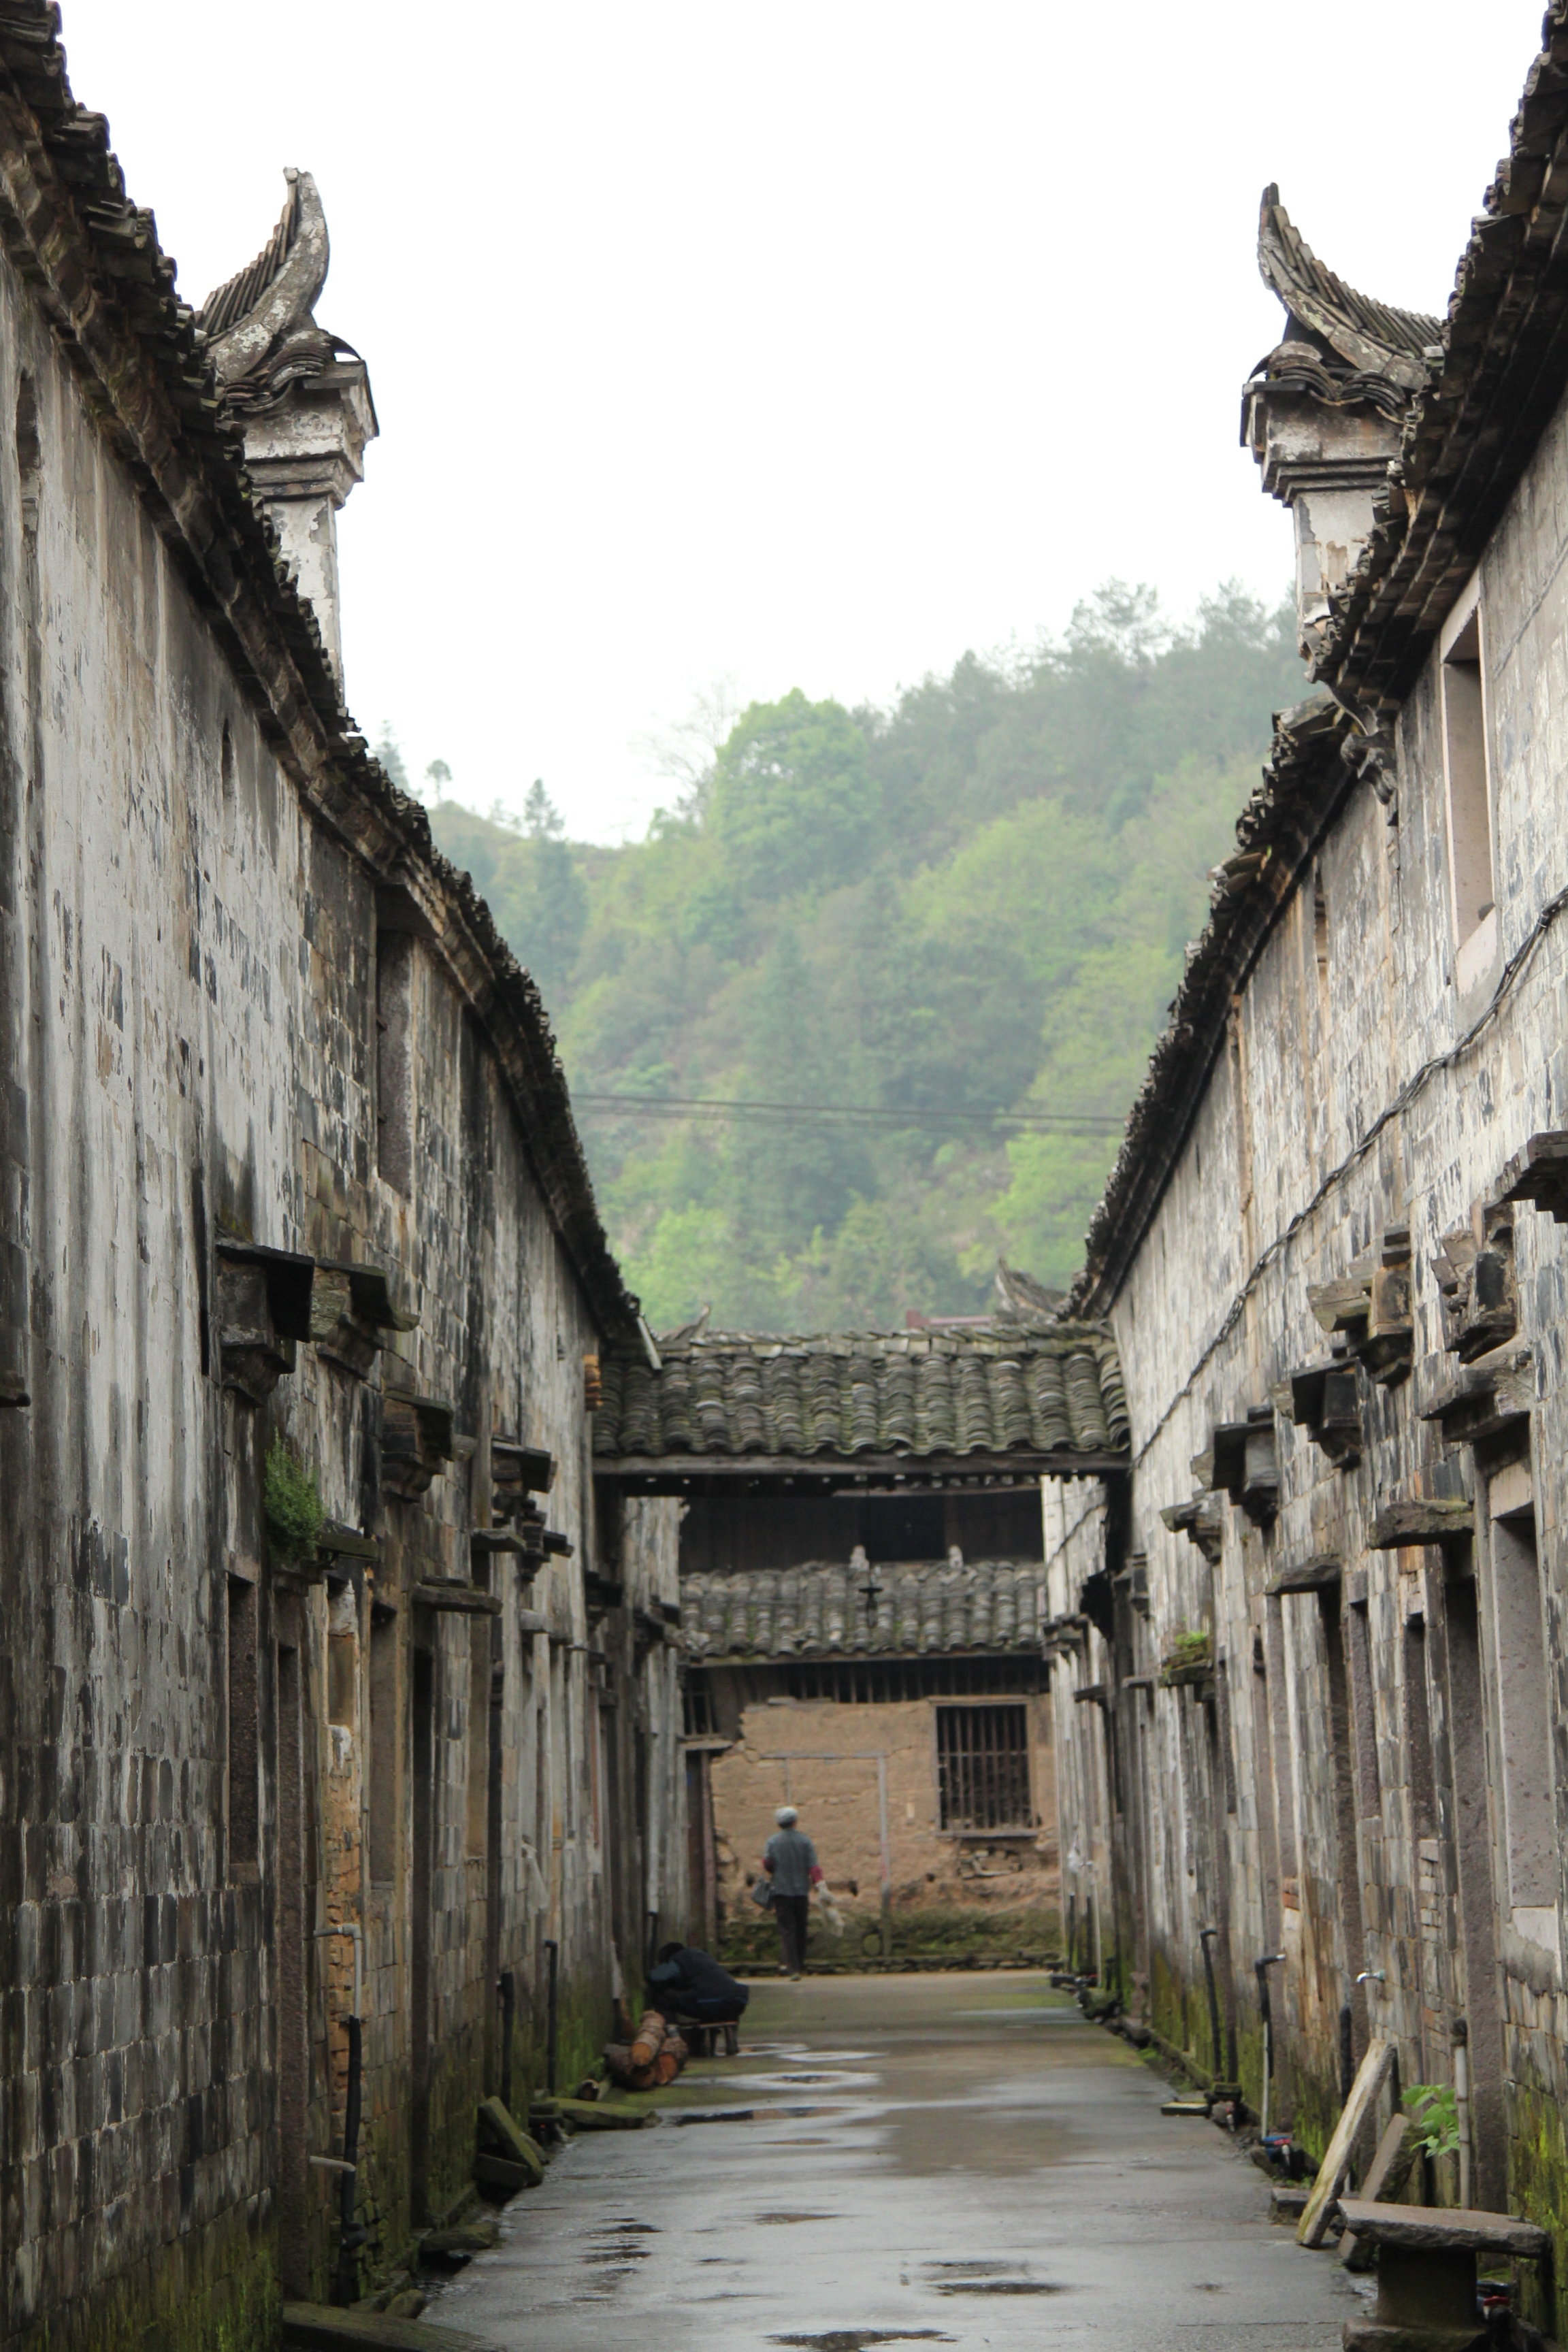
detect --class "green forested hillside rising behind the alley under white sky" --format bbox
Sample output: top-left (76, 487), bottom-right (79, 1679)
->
top-left (430, 586), bottom-right (1305, 1329)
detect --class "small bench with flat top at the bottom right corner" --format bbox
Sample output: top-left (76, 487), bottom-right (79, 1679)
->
top-left (1340, 2197), bottom-right (1549, 2352)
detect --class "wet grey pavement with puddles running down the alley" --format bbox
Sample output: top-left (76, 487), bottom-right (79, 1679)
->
top-left (425, 1974), bottom-right (1366, 2352)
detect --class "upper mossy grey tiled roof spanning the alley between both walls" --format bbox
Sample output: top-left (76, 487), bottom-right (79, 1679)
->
top-left (592, 1320), bottom-right (1128, 1460)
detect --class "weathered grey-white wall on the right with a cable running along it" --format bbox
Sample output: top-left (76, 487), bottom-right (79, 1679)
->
top-left (1046, 353), bottom-right (1568, 2333)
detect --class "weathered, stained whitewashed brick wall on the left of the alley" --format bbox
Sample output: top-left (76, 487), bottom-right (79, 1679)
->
top-left (0, 174), bottom-right (684, 2352)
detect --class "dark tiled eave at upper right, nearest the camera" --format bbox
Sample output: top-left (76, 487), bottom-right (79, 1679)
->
top-left (1311, 0), bottom-right (1568, 713)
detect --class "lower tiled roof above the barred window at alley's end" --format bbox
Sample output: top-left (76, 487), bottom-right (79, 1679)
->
top-left (682, 1554), bottom-right (1046, 1661)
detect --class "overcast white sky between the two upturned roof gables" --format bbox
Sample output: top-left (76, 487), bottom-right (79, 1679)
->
top-left (63, 0), bottom-right (1542, 840)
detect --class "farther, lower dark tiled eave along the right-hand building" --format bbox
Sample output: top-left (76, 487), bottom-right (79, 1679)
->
top-left (1072, 689), bottom-right (1356, 1315)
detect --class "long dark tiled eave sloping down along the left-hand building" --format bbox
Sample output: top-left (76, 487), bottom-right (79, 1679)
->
top-left (0, 0), bottom-right (637, 1334)
